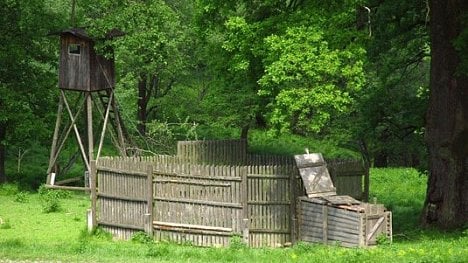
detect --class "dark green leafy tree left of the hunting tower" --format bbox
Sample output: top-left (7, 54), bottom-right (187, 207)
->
top-left (0, 0), bottom-right (63, 183)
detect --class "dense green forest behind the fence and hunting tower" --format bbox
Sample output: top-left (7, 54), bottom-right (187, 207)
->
top-left (0, 0), bottom-right (468, 229)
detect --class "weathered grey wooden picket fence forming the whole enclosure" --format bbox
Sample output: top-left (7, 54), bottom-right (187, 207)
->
top-left (92, 142), bottom-right (365, 247)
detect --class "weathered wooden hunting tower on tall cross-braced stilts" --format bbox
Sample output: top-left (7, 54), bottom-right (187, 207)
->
top-left (47, 28), bottom-right (128, 193)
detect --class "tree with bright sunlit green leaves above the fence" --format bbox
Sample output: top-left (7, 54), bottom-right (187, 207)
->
top-left (199, 0), bottom-right (365, 136)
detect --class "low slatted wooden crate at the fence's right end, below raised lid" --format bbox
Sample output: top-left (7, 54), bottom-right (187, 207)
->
top-left (297, 196), bottom-right (392, 247)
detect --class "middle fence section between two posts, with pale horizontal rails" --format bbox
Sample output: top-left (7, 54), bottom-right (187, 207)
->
top-left (153, 165), bottom-right (246, 246)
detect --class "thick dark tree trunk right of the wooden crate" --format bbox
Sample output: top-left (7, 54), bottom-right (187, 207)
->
top-left (422, 0), bottom-right (468, 228)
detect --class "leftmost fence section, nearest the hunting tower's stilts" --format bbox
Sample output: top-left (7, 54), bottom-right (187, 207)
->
top-left (96, 159), bottom-right (153, 239)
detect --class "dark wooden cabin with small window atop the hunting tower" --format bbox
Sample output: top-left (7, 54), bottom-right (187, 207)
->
top-left (59, 29), bottom-right (115, 91)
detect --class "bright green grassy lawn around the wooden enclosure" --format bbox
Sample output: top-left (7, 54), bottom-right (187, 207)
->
top-left (0, 168), bottom-right (468, 262)
